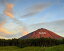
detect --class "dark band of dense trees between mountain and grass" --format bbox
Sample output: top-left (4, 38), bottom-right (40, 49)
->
top-left (0, 38), bottom-right (64, 47)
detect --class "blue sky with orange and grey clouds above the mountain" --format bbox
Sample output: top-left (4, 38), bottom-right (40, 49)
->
top-left (0, 0), bottom-right (64, 39)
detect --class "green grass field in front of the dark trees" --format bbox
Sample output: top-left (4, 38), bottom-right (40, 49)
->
top-left (0, 45), bottom-right (64, 51)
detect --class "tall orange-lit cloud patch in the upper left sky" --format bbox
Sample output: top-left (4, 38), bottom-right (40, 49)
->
top-left (4, 3), bottom-right (14, 18)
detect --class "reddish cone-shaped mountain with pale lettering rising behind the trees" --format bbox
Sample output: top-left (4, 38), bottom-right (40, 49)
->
top-left (21, 28), bottom-right (63, 39)
